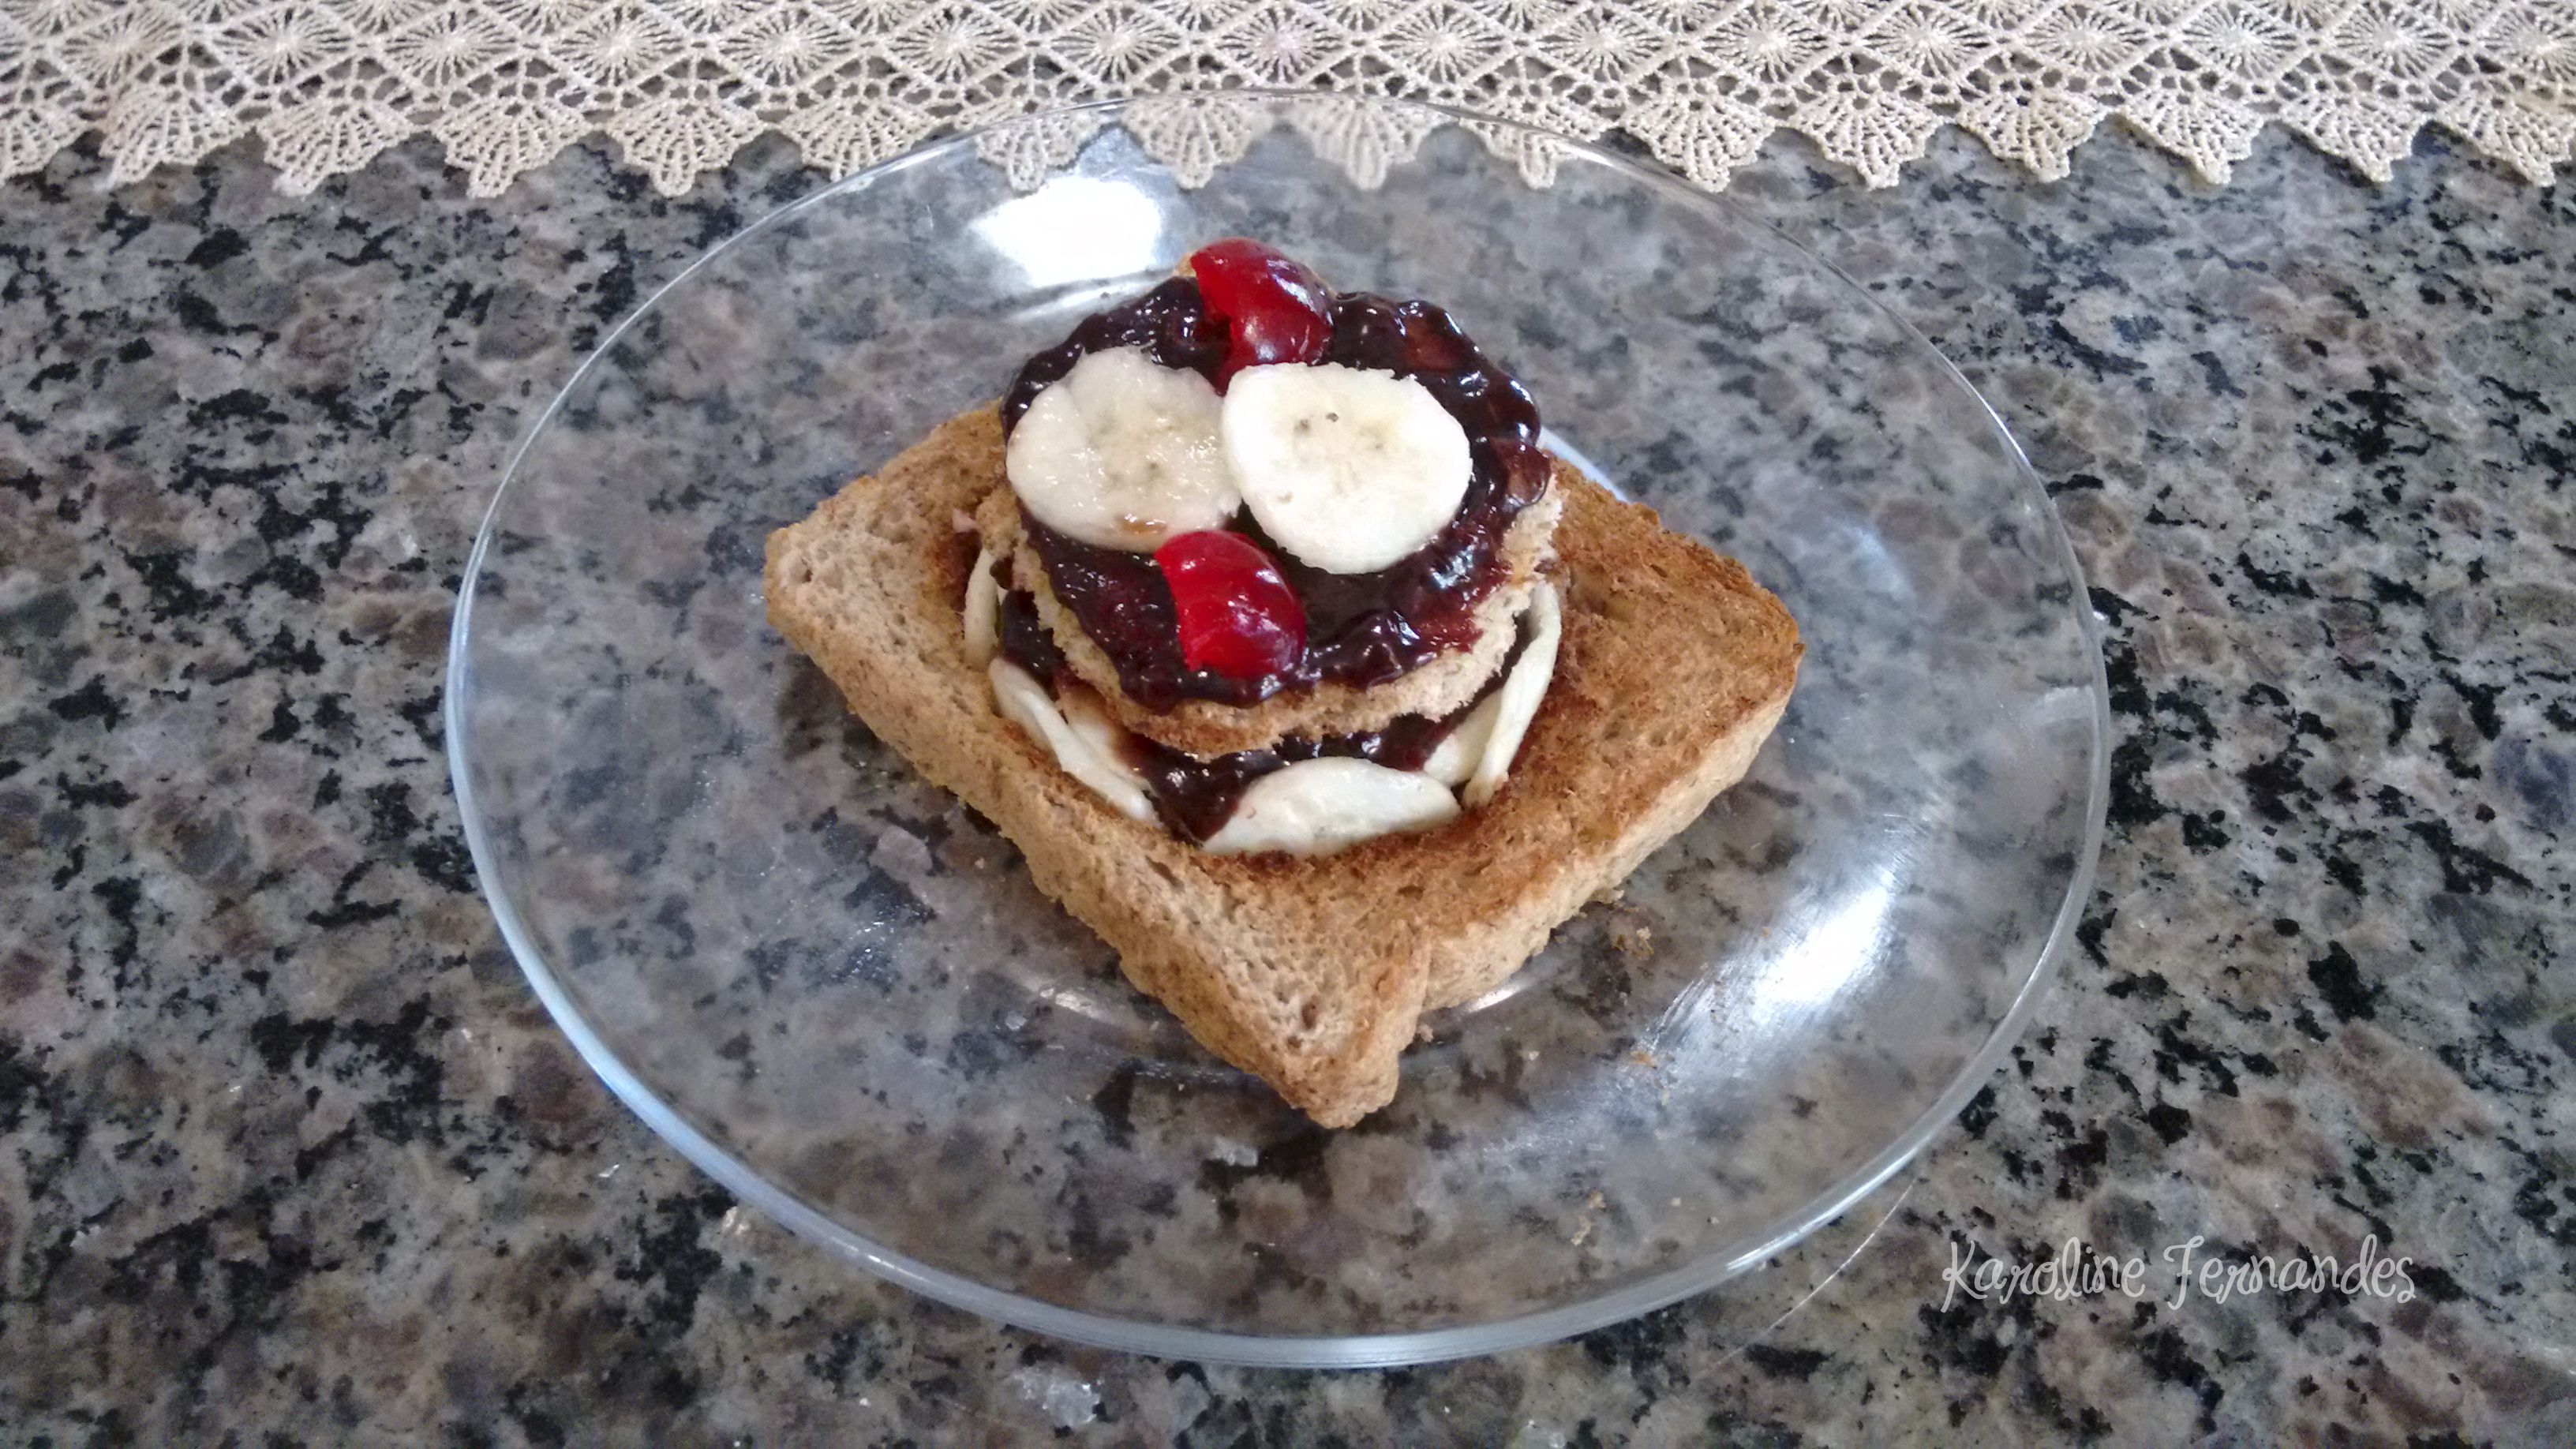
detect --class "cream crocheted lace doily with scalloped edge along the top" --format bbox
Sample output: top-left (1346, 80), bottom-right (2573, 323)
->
top-left (0, 0), bottom-right (2576, 196)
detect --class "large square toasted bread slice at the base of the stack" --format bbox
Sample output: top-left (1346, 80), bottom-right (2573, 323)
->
top-left (762, 407), bottom-right (1801, 1127)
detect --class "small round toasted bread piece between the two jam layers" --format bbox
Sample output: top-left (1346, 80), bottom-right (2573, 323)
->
top-left (974, 469), bottom-right (1582, 761)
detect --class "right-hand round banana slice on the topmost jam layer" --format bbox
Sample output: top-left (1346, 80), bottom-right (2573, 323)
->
top-left (1226, 364), bottom-right (1468, 572)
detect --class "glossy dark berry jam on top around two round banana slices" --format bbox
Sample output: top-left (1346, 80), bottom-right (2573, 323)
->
top-left (1002, 279), bottom-right (1548, 712)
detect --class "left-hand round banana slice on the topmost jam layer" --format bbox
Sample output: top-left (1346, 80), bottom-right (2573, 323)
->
top-left (1002, 348), bottom-right (1241, 552)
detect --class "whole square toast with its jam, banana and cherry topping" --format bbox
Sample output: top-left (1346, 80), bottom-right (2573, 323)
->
top-left (762, 240), bottom-right (1801, 1127)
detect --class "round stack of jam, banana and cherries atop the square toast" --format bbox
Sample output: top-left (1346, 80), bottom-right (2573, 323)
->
top-left (964, 240), bottom-right (1561, 856)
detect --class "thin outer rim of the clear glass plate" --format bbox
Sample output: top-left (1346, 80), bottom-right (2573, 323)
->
top-left (440, 88), bottom-right (2110, 1369)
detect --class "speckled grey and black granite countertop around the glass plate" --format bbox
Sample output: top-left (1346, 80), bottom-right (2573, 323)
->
top-left (0, 132), bottom-right (2576, 1443)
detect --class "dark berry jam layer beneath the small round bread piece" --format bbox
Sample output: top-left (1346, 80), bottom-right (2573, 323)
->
top-left (1002, 590), bottom-right (1530, 846)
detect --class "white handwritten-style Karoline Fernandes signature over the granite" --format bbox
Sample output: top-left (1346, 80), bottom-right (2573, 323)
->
top-left (1940, 1233), bottom-right (2413, 1312)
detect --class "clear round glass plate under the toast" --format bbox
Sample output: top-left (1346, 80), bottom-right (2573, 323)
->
top-left (446, 98), bottom-right (2107, 1364)
